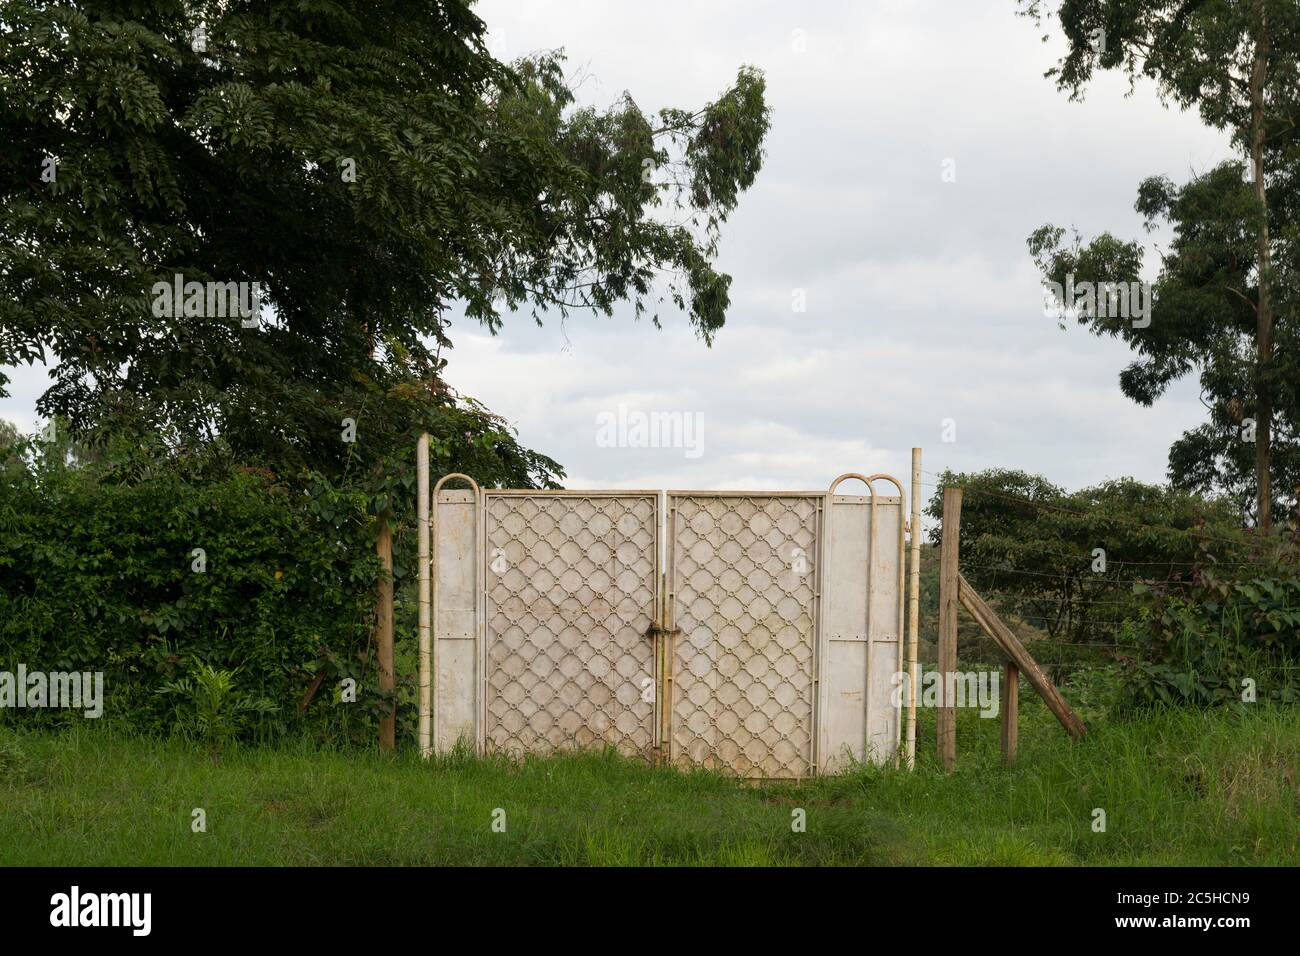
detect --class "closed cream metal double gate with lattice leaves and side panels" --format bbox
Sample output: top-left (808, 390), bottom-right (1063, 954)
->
top-left (430, 475), bottom-right (905, 778)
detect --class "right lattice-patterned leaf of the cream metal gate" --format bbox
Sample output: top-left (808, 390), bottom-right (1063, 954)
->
top-left (671, 496), bottom-right (818, 778)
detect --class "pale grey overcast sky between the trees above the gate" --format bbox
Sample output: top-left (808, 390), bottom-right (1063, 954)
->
top-left (0, 0), bottom-right (1230, 502)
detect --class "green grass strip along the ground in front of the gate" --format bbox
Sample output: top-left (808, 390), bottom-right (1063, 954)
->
top-left (0, 695), bottom-right (1300, 865)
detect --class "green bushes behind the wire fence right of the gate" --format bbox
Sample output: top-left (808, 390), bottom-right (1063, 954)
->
top-left (923, 470), bottom-right (1300, 708)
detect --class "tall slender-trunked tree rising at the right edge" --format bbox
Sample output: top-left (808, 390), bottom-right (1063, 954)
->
top-left (1021, 0), bottom-right (1300, 529)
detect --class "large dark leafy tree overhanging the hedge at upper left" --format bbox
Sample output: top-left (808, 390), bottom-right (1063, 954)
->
top-left (0, 0), bottom-right (768, 473)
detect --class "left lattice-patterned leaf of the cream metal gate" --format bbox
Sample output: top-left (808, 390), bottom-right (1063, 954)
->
top-left (485, 494), bottom-right (658, 756)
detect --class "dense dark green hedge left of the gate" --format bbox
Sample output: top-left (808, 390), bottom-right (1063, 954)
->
top-left (0, 434), bottom-right (378, 732)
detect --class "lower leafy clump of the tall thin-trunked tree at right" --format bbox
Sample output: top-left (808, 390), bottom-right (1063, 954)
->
top-left (1028, 163), bottom-right (1300, 514)
